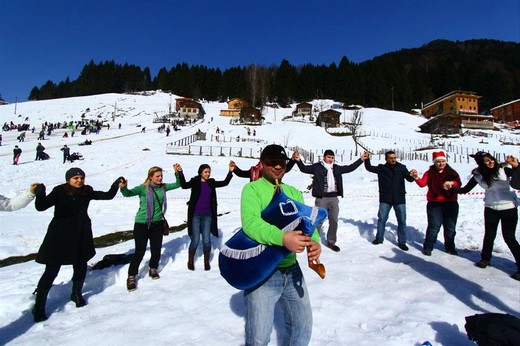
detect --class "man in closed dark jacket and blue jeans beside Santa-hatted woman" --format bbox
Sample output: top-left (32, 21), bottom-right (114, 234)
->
top-left (365, 151), bottom-right (414, 251)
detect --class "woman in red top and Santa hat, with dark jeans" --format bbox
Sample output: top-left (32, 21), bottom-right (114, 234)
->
top-left (410, 151), bottom-right (462, 256)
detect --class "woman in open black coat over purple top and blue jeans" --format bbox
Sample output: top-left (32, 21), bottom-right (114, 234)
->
top-left (174, 161), bottom-right (235, 270)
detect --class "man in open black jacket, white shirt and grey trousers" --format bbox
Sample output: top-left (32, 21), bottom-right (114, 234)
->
top-left (292, 150), bottom-right (368, 252)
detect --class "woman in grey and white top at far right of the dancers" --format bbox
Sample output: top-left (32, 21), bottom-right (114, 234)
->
top-left (454, 151), bottom-right (520, 280)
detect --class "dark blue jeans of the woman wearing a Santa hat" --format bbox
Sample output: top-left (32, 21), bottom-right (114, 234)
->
top-left (423, 201), bottom-right (459, 251)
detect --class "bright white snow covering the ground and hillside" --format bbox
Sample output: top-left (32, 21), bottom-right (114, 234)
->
top-left (0, 92), bottom-right (520, 346)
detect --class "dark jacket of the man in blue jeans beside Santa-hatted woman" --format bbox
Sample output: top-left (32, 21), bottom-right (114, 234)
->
top-left (365, 159), bottom-right (415, 205)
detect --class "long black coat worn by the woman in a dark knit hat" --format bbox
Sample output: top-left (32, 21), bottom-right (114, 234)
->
top-left (35, 181), bottom-right (118, 265)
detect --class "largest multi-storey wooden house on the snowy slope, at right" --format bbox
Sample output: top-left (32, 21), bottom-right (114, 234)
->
top-left (419, 90), bottom-right (493, 134)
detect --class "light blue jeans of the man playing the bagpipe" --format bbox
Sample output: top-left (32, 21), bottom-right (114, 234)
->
top-left (244, 263), bottom-right (312, 346)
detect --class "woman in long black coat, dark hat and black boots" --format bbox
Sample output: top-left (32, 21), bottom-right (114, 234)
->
top-left (32, 168), bottom-right (123, 322)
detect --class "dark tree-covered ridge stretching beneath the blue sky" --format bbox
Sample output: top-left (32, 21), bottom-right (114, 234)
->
top-left (29, 39), bottom-right (520, 113)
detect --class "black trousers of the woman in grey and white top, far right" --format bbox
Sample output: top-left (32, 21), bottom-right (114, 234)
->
top-left (481, 208), bottom-right (520, 270)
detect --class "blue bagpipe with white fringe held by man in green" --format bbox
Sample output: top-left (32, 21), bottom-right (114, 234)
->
top-left (218, 186), bottom-right (327, 290)
